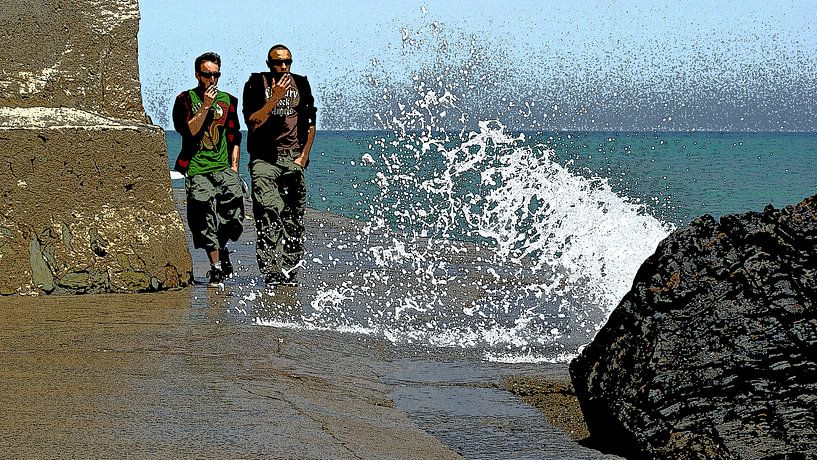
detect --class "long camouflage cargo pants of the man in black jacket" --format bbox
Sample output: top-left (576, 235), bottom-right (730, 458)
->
top-left (250, 150), bottom-right (306, 281)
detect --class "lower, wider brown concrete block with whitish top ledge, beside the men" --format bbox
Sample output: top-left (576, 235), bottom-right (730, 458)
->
top-left (0, 108), bottom-right (192, 294)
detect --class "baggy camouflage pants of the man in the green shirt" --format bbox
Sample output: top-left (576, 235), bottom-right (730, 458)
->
top-left (184, 168), bottom-right (244, 251)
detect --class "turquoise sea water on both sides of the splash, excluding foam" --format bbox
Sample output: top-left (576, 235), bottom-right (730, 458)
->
top-left (167, 131), bottom-right (817, 225)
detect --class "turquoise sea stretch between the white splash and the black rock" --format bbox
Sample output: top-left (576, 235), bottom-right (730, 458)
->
top-left (555, 133), bottom-right (817, 224)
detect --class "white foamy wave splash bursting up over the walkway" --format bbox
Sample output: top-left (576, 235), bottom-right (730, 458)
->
top-left (250, 21), bottom-right (672, 362)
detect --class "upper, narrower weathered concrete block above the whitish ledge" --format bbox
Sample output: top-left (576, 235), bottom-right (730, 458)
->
top-left (0, 0), bottom-right (146, 123)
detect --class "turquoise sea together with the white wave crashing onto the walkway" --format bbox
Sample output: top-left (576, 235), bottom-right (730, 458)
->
top-left (166, 127), bottom-right (817, 363)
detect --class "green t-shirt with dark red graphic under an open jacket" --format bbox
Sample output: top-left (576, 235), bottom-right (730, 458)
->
top-left (187, 90), bottom-right (230, 176)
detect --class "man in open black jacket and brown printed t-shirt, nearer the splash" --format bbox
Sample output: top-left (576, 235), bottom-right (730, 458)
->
top-left (244, 45), bottom-right (316, 285)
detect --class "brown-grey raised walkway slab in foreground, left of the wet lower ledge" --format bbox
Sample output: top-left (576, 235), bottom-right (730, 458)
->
top-left (0, 290), bottom-right (458, 459)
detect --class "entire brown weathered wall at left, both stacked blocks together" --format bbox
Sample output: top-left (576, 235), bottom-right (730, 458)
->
top-left (0, 0), bottom-right (192, 294)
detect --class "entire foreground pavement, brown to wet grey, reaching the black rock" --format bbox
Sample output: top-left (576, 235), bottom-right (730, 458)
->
top-left (0, 191), bottom-right (613, 459)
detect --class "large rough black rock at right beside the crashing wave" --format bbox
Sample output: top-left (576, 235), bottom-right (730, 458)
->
top-left (570, 196), bottom-right (817, 459)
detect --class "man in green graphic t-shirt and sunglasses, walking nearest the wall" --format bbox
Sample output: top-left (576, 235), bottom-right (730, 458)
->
top-left (173, 52), bottom-right (244, 286)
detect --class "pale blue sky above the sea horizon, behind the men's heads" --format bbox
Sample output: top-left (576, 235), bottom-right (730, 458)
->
top-left (139, 0), bottom-right (817, 130)
